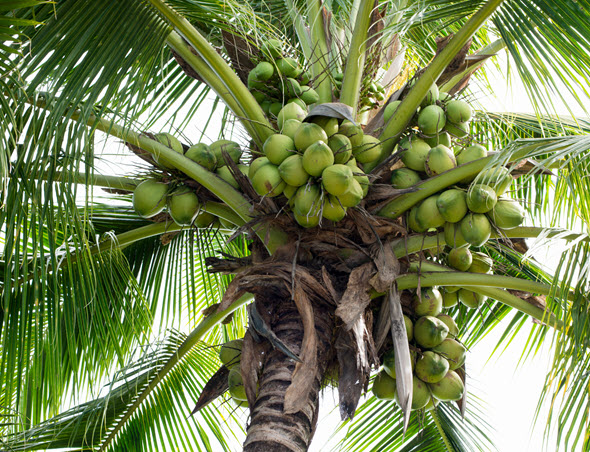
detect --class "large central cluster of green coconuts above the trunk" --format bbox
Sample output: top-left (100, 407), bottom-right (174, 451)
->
top-left (248, 103), bottom-right (382, 228)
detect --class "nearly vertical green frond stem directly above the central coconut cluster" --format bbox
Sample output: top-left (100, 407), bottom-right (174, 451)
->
top-left (307, 0), bottom-right (332, 103)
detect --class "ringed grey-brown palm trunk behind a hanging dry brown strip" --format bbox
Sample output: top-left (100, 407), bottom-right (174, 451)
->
top-left (244, 298), bottom-right (333, 452)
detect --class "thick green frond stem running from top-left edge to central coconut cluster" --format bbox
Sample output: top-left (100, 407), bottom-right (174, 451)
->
top-left (148, 0), bottom-right (274, 148)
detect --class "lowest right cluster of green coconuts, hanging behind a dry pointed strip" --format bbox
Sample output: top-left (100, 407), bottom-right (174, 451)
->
top-left (372, 288), bottom-right (466, 410)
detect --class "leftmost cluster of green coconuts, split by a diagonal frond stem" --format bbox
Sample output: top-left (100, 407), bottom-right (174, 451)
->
top-left (133, 133), bottom-right (248, 228)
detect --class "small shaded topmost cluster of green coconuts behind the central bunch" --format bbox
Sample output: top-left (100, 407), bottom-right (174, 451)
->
top-left (248, 39), bottom-right (319, 118)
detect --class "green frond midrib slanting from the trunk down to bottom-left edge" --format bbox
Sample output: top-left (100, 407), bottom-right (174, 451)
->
top-left (99, 294), bottom-right (252, 451)
